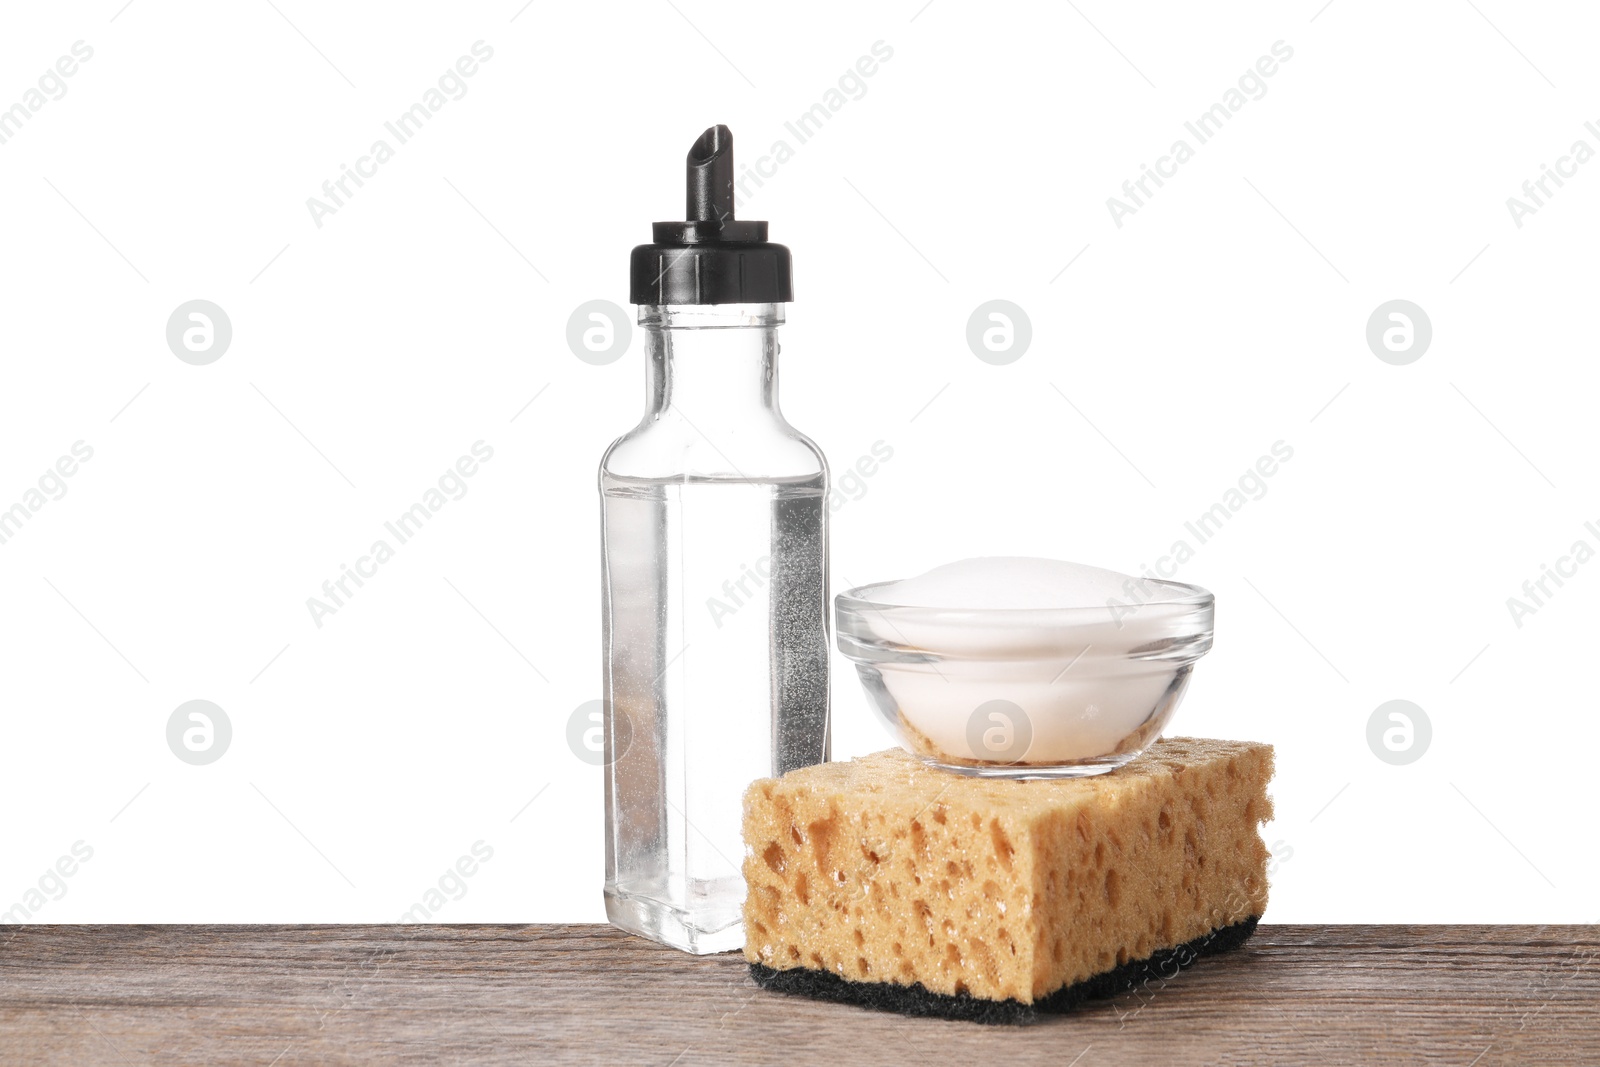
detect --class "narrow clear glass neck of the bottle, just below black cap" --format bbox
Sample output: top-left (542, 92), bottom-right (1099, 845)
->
top-left (638, 304), bottom-right (784, 424)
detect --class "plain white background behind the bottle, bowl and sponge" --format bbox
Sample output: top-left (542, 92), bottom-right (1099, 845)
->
top-left (0, 0), bottom-right (1600, 921)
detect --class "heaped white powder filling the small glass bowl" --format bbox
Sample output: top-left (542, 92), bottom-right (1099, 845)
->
top-left (861, 557), bottom-right (1210, 765)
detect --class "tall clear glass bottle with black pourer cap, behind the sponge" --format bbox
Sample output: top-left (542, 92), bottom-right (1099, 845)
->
top-left (600, 126), bottom-right (829, 953)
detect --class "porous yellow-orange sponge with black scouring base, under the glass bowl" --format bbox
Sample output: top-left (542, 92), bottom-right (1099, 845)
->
top-left (744, 737), bottom-right (1272, 1022)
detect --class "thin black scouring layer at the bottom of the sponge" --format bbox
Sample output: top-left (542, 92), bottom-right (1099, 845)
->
top-left (750, 915), bottom-right (1259, 1025)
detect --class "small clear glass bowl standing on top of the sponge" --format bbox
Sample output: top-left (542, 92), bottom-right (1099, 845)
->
top-left (834, 579), bottom-right (1214, 777)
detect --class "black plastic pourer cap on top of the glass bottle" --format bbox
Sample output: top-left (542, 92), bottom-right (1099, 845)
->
top-left (627, 126), bottom-right (794, 304)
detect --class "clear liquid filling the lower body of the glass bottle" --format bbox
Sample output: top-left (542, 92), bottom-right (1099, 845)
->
top-left (602, 475), bottom-right (829, 952)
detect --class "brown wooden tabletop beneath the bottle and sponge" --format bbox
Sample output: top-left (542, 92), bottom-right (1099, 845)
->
top-left (0, 925), bottom-right (1600, 1067)
